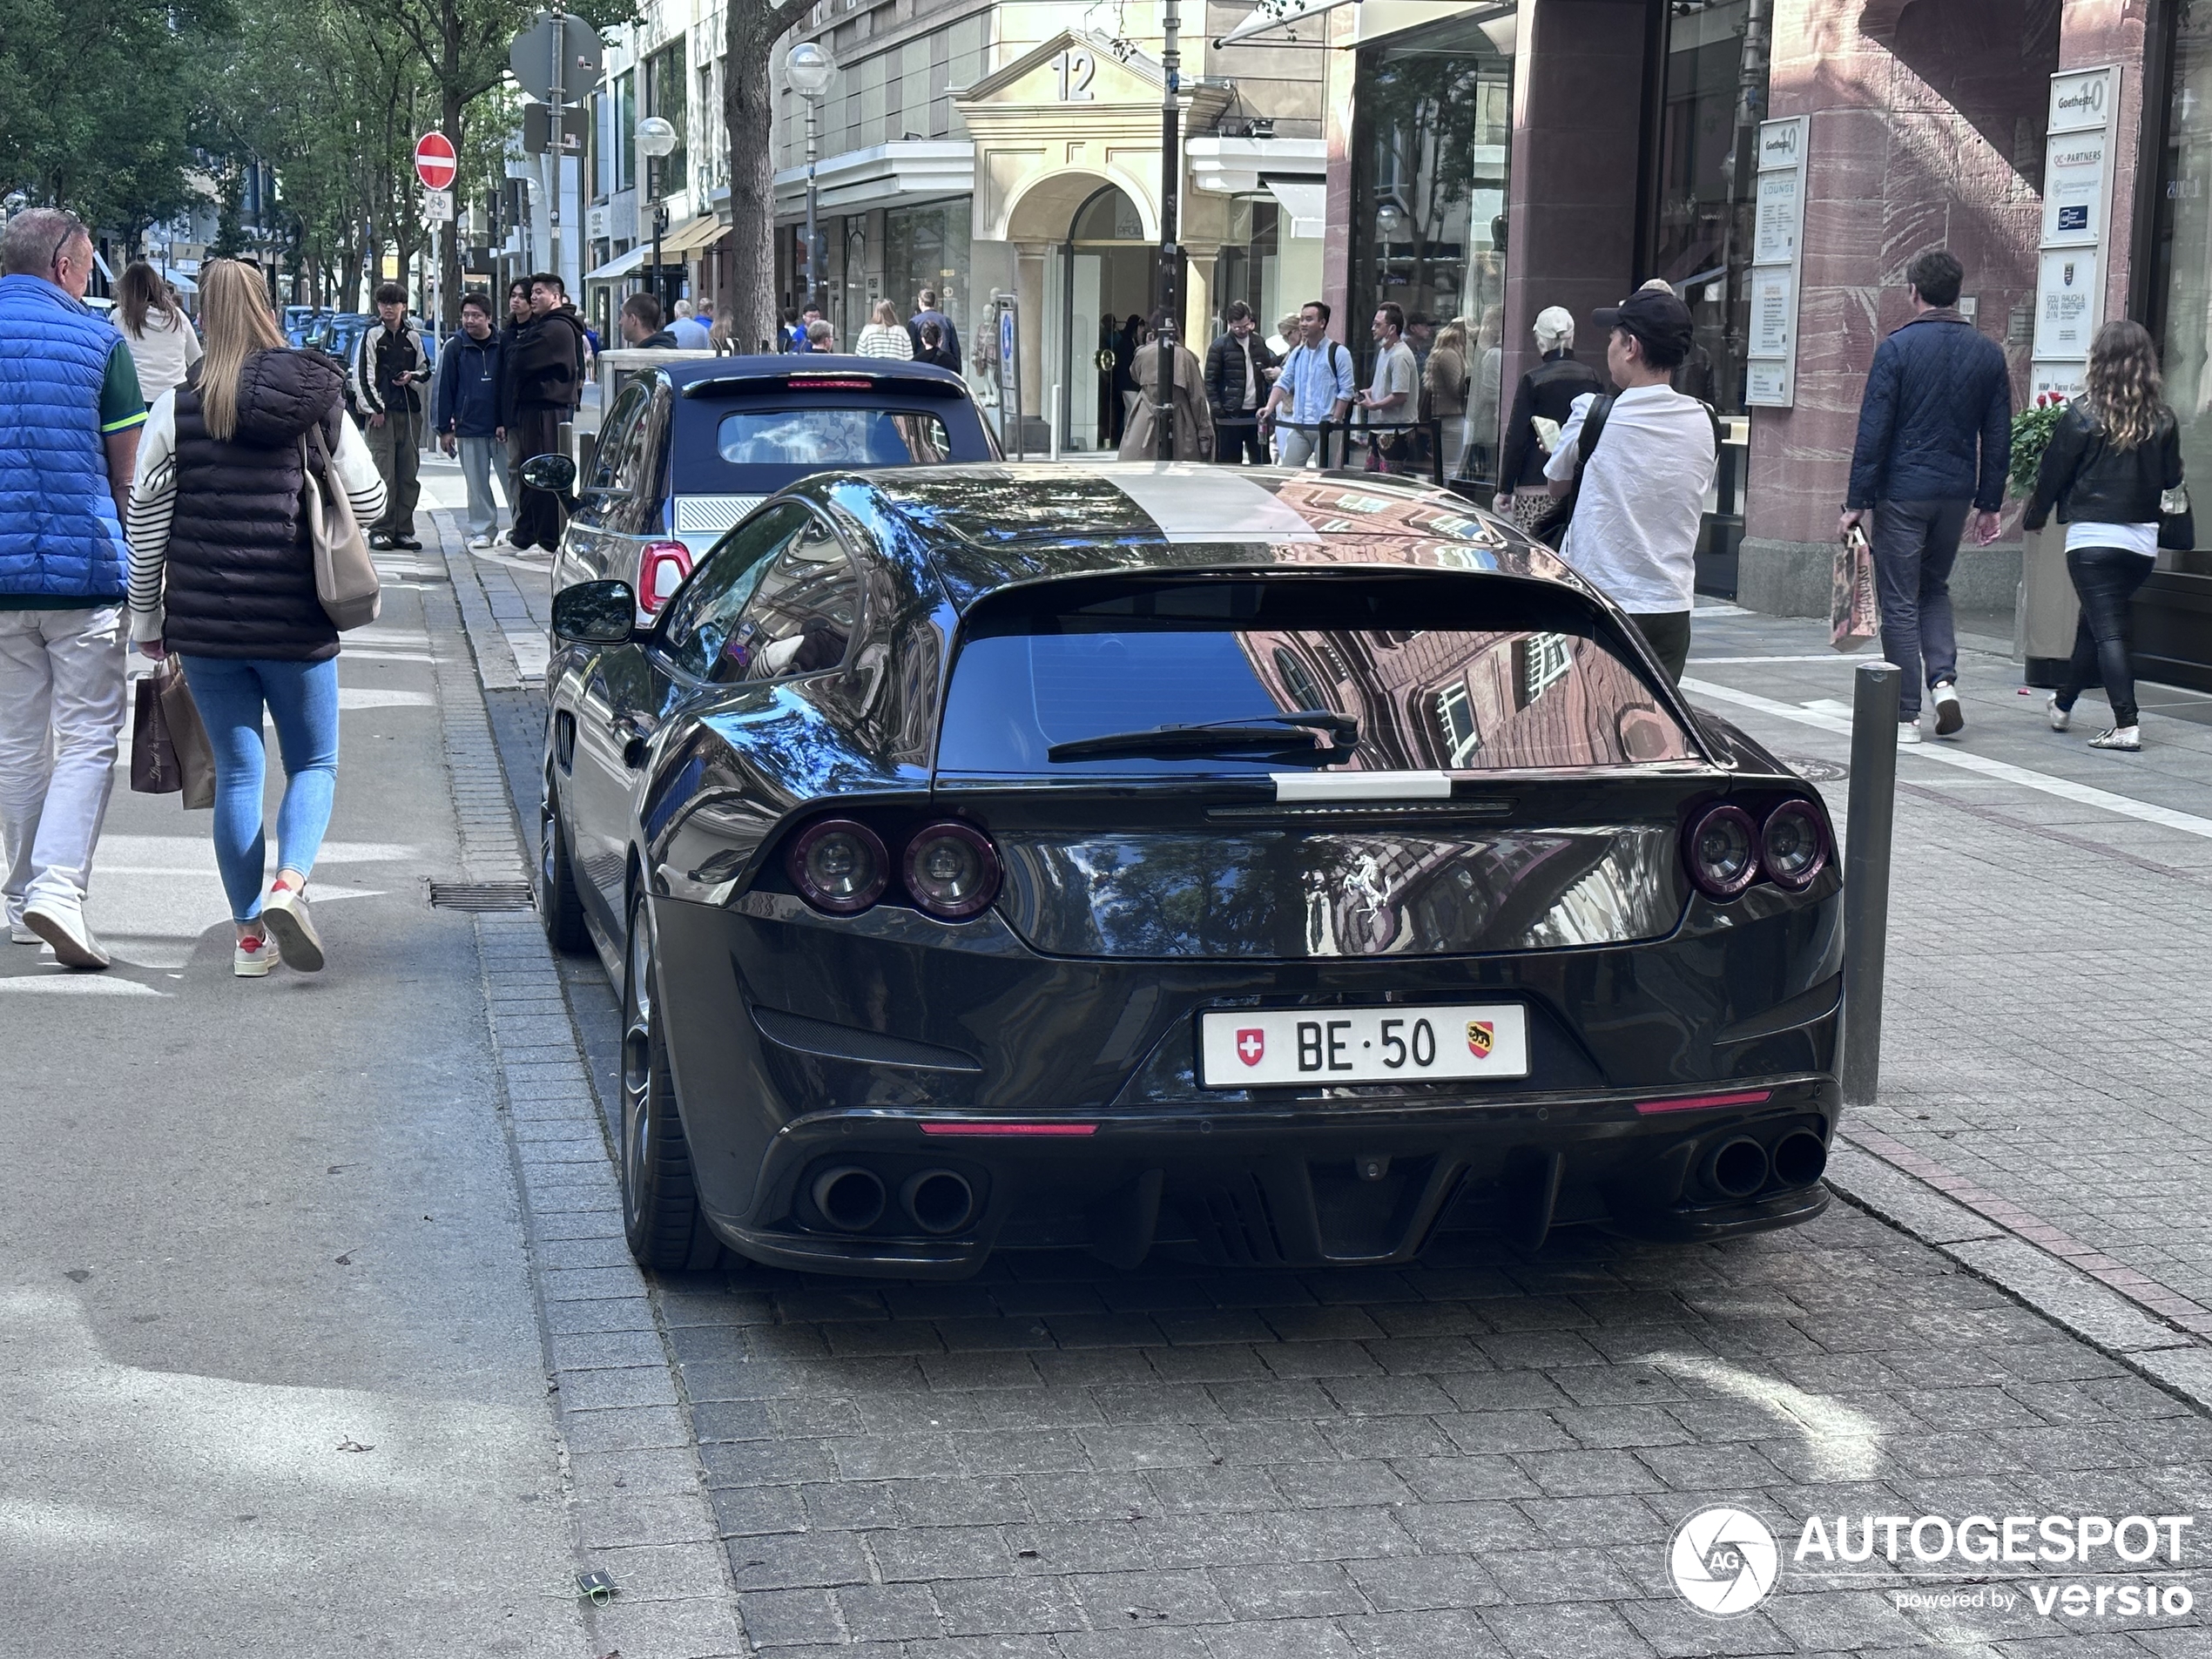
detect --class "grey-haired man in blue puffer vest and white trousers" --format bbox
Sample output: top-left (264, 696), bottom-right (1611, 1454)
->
top-left (0, 208), bottom-right (146, 969)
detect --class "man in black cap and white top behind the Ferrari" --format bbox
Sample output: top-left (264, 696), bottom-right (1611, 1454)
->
top-left (1544, 290), bottom-right (1721, 679)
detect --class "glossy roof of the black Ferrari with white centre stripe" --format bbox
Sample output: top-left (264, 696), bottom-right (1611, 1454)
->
top-left (803, 462), bottom-right (1595, 610)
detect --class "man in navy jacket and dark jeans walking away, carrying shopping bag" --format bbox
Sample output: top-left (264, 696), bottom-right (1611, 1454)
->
top-left (1836, 247), bottom-right (2013, 743)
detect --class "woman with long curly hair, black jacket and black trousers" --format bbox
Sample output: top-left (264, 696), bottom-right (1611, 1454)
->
top-left (2027, 319), bottom-right (2181, 752)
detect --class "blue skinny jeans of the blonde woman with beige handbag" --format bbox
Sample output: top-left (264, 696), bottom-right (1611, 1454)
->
top-left (181, 657), bottom-right (339, 922)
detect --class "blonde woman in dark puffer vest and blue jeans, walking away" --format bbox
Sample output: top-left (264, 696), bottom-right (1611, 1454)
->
top-left (128, 259), bottom-right (385, 980)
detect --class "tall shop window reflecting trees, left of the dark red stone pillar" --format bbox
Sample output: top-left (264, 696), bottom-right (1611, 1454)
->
top-left (1336, 4), bottom-right (1517, 482)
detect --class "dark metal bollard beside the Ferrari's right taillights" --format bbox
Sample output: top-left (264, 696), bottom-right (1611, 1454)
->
top-left (1843, 661), bottom-right (1905, 1110)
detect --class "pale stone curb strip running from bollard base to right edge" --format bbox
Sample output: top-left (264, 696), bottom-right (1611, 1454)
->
top-left (1827, 1135), bottom-right (2212, 1416)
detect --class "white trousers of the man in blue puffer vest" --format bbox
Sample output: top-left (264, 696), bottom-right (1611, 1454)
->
top-left (0, 599), bottom-right (126, 925)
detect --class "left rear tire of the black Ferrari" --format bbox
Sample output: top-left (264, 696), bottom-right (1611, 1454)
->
top-left (619, 898), bottom-right (728, 1272)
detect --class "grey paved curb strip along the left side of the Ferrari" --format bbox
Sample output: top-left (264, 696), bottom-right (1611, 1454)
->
top-left (425, 513), bottom-right (750, 1659)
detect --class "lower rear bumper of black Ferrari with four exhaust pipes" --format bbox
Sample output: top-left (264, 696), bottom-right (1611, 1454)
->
top-left (710, 1075), bottom-right (1838, 1278)
